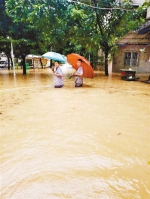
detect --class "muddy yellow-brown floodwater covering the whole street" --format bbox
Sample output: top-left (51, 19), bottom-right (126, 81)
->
top-left (0, 67), bottom-right (150, 199)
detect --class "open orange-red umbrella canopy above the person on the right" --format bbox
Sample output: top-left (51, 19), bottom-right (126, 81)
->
top-left (67, 53), bottom-right (94, 78)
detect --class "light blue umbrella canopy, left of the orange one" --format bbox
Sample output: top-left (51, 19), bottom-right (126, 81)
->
top-left (42, 52), bottom-right (66, 62)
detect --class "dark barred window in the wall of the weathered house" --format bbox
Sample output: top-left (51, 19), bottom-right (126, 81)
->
top-left (124, 52), bottom-right (138, 66)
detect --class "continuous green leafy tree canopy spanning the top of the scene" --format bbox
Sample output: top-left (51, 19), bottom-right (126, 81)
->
top-left (0, 0), bottom-right (149, 74)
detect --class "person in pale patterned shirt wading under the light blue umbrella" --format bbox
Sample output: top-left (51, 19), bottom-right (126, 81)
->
top-left (52, 61), bottom-right (64, 88)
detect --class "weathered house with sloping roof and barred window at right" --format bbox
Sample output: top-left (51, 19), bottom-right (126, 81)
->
top-left (112, 8), bottom-right (150, 73)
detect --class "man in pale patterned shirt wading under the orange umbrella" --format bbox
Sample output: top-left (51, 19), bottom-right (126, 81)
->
top-left (72, 59), bottom-right (83, 87)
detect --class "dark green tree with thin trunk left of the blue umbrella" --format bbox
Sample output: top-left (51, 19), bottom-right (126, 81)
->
top-left (5, 0), bottom-right (53, 74)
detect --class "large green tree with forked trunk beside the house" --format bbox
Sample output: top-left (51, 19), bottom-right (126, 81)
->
top-left (71, 0), bottom-right (146, 76)
